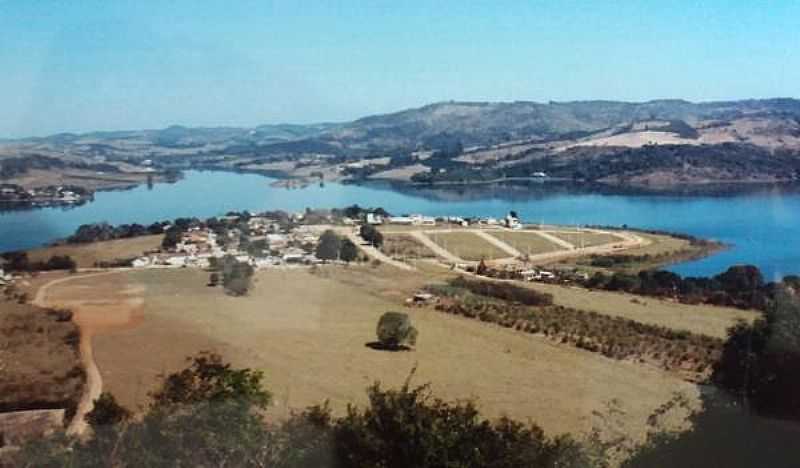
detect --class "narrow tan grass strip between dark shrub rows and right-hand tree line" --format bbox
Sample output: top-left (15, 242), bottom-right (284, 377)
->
top-left (528, 283), bottom-right (758, 338)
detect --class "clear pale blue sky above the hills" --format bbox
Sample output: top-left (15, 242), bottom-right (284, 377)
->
top-left (0, 0), bottom-right (800, 138)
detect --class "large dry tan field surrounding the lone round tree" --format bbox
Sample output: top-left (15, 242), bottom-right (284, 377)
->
top-left (39, 266), bottom-right (697, 438)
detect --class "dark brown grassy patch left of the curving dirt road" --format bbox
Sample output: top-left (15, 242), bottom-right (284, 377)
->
top-left (0, 299), bottom-right (84, 411)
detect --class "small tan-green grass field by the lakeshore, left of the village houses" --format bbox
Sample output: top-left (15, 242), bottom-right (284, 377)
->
top-left (28, 234), bottom-right (163, 268)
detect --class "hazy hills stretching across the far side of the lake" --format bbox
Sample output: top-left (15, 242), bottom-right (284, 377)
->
top-left (0, 98), bottom-right (800, 192)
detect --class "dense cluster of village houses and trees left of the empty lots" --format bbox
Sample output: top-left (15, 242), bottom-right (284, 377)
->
top-left (132, 217), bottom-right (328, 269)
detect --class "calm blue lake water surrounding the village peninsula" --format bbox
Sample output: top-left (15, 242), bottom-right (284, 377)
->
top-left (0, 172), bottom-right (800, 279)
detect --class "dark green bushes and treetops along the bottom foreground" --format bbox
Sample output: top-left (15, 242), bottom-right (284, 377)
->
top-left (6, 354), bottom-right (596, 468)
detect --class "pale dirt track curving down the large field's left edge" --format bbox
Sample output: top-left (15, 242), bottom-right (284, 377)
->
top-left (32, 269), bottom-right (130, 436)
